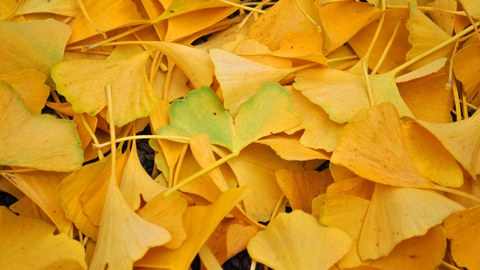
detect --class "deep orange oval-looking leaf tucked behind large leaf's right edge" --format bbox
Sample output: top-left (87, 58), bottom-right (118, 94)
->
top-left (402, 122), bottom-right (463, 188)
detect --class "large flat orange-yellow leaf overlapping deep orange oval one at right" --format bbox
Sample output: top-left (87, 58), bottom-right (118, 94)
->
top-left (331, 103), bottom-right (433, 187)
